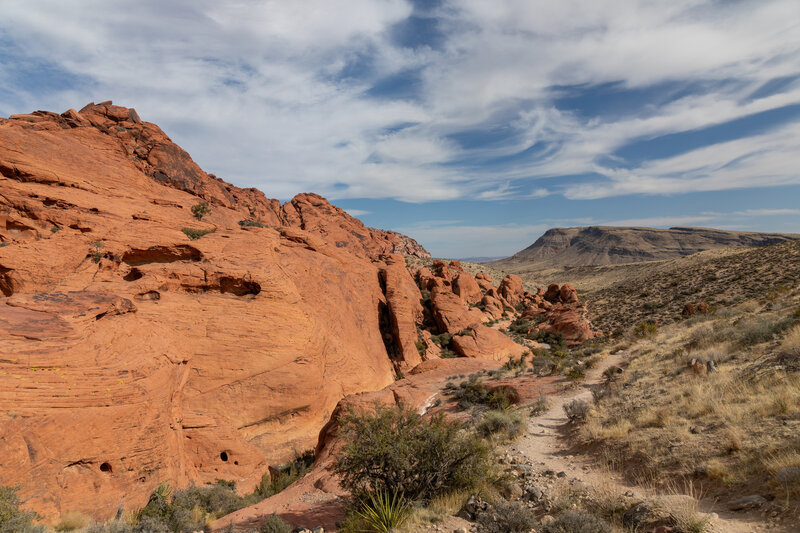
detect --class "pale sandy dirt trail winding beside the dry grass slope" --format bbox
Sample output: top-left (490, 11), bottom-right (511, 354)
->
top-left (508, 353), bottom-right (776, 533)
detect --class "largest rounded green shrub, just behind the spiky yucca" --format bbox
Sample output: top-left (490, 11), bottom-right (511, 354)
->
top-left (335, 406), bottom-right (491, 500)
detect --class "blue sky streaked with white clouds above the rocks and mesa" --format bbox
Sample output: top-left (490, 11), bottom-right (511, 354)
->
top-left (0, 0), bottom-right (800, 257)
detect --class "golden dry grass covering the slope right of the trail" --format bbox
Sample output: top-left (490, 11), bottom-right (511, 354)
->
top-left (576, 300), bottom-right (800, 502)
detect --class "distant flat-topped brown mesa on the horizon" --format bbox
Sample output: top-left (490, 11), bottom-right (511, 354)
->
top-left (492, 226), bottom-right (800, 269)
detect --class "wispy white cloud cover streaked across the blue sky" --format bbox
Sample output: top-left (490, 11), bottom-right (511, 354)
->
top-left (0, 0), bottom-right (800, 205)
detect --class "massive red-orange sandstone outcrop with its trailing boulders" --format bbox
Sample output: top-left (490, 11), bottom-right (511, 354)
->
top-left (0, 102), bottom-right (594, 519)
